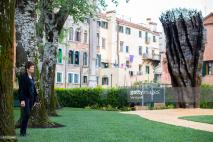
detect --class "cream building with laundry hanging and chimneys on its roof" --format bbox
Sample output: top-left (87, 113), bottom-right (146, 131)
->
top-left (97, 11), bottom-right (161, 87)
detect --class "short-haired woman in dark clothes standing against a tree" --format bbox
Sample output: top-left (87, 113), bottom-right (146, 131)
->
top-left (19, 61), bottom-right (38, 136)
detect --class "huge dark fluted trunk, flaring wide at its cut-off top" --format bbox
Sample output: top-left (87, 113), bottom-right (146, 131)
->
top-left (160, 9), bottom-right (204, 108)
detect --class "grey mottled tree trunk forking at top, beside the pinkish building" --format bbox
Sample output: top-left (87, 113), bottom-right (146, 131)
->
top-left (41, 8), bottom-right (68, 115)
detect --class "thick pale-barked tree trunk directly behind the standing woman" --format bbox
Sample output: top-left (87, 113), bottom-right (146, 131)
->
top-left (16, 0), bottom-right (49, 127)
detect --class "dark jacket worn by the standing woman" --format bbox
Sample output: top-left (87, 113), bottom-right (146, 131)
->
top-left (18, 73), bottom-right (38, 103)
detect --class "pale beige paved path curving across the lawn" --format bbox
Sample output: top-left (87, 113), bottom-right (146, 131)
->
top-left (121, 109), bottom-right (213, 132)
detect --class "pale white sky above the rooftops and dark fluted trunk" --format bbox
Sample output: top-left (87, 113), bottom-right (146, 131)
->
top-left (106, 0), bottom-right (213, 31)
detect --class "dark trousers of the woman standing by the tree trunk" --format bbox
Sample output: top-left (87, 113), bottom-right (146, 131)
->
top-left (20, 99), bottom-right (33, 134)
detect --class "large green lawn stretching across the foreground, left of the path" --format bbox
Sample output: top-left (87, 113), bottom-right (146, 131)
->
top-left (15, 108), bottom-right (213, 142)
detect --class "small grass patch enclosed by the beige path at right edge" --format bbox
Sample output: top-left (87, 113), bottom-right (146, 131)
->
top-left (180, 115), bottom-right (213, 124)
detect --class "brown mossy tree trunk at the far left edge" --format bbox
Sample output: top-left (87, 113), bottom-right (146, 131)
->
top-left (0, 0), bottom-right (16, 142)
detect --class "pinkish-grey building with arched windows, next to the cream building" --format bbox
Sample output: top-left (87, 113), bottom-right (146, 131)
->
top-left (55, 17), bottom-right (89, 88)
